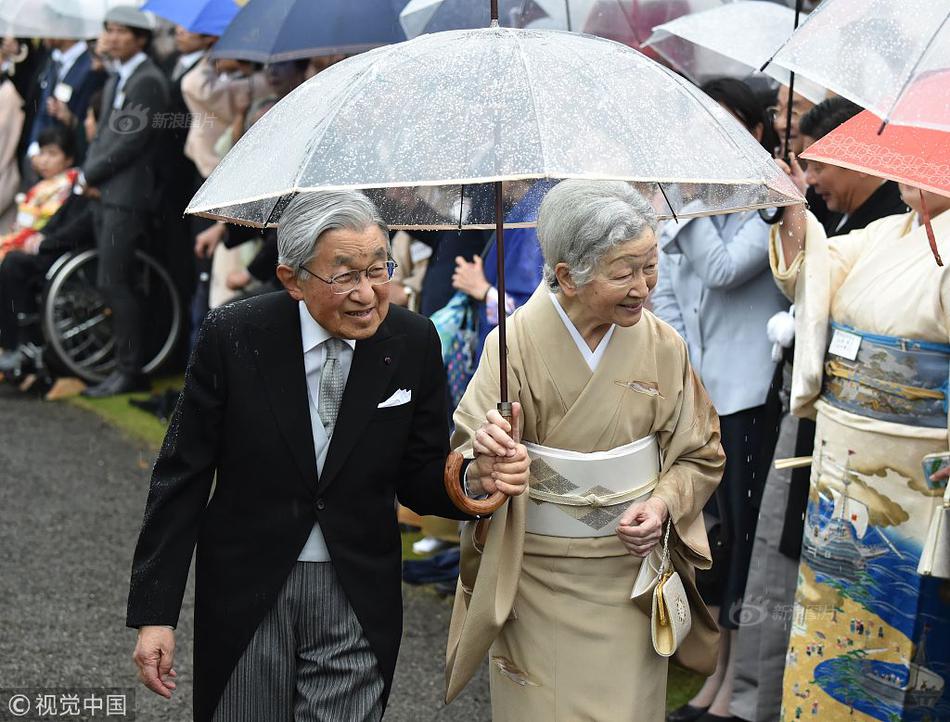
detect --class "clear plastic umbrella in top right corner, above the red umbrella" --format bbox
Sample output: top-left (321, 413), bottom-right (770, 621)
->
top-left (772, 0), bottom-right (950, 130)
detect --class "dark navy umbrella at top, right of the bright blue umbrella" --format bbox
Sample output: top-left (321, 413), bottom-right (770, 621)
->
top-left (212, 0), bottom-right (406, 63)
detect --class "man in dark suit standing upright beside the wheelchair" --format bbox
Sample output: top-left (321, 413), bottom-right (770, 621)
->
top-left (79, 5), bottom-right (168, 397)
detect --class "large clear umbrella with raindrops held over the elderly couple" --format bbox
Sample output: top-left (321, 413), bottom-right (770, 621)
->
top-left (188, 28), bottom-right (802, 228)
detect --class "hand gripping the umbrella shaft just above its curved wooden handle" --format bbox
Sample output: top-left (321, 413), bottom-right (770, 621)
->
top-left (468, 402), bottom-right (531, 496)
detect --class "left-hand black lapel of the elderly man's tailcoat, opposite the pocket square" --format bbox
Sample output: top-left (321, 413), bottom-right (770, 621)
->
top-left (247, 296), bottom-right (317, 493)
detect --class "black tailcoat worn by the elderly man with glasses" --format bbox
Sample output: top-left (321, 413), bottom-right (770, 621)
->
top-left (127, 291), bottom-right (470, 720)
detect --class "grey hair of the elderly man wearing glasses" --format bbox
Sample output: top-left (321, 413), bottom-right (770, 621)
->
top-left (277, 191), bottom-right (389, 275)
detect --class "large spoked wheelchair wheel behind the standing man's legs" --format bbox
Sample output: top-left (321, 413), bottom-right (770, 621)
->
top-left (42, 249), bottom-right (182, 383)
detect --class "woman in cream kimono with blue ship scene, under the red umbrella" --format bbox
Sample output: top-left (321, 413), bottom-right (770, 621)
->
top-left (771, 186), bottom-right (950, 722)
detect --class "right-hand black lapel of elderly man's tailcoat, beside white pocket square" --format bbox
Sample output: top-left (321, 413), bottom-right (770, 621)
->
top-left (318, 322), bottom-right (404, 491)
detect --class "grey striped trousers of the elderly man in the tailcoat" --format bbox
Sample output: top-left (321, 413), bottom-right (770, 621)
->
top-left (214, 562), bottom-right (383, 722)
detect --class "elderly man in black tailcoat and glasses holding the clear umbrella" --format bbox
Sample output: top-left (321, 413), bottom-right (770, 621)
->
top-left (127, 191), bottom-right (528, 722)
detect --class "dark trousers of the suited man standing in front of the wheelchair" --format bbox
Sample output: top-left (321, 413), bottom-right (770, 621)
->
top-left (93, 203), bottom-right (146, 376)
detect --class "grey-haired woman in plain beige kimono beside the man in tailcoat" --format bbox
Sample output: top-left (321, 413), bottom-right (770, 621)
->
top-left (446, 180), bottom-right (724, 722)
